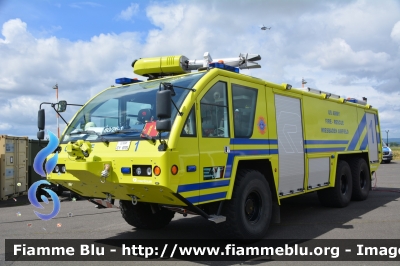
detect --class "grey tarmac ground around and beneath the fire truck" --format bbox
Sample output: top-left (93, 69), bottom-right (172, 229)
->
top-left (0, 161), bottom-right (400, 266)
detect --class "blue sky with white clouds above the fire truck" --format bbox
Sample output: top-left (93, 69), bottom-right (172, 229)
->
top-left (0, 0), bottom-right (400, 139)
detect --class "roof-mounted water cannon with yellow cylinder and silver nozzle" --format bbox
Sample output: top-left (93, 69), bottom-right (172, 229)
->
top-left (132, 52), bottom-right (261, 79)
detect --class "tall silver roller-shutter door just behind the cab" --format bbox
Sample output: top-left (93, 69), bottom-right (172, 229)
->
top-left (275, 94), bottom-right (304, 196)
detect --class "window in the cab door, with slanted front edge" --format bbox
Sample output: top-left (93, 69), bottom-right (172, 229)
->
top-left (200, 81), bottom-right (229, 138)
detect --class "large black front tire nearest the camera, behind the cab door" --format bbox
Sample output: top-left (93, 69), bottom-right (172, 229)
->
top-left (215, 169), bottom-right (272, 242)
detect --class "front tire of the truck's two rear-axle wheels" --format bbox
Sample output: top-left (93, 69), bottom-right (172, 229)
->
top-left (317, 161), bottom-right (353, 208)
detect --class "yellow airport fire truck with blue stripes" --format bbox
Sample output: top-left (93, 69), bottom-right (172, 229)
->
top-left (38, 53), bottom-right (382, 239)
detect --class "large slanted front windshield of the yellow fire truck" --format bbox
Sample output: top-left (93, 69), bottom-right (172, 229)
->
top-left (61, 72), bottom-right (205, 143)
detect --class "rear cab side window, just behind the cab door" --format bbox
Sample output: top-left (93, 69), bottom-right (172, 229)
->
top-left (232, 84), bottom-right (257, 138)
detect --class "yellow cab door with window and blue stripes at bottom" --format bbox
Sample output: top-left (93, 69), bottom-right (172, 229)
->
top-left (197, 77), bottom-right (231, 204)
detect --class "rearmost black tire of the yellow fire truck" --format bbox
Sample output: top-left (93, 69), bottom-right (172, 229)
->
top-left (350, 158), bottom-right (371, 200)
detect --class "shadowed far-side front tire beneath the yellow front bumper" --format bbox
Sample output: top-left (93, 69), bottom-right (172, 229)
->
top-left (119, 200), bottom-right (175, 229)
